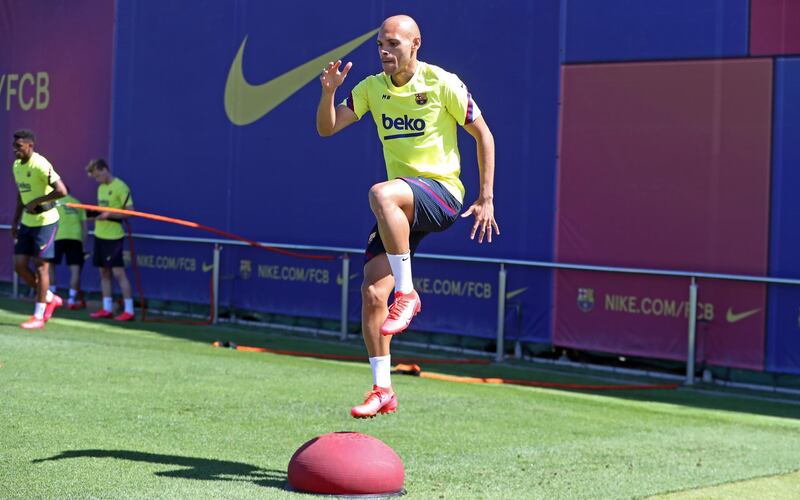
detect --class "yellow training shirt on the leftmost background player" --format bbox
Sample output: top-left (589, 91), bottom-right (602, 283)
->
top-left (12, 153), bottom-right (61, 227)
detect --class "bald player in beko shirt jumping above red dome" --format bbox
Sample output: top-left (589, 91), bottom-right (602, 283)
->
top-left (317, 16), bottom-right (500, 418)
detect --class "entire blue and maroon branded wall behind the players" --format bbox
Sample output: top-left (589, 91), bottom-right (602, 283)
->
top-left (0, 0), bottom-right (800, 373)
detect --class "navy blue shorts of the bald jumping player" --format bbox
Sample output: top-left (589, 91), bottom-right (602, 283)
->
top-left (364, 177), bottom-right (461, 263)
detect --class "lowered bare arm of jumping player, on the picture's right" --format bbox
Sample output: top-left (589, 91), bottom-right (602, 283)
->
top-left (461, 116), bottom-right (500, 243)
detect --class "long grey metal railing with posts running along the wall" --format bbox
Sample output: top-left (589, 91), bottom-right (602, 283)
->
top-left (0, 224), bottom-right (800, 385)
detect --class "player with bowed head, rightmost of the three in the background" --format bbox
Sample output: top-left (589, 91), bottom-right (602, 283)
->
top-left (86, 158), bottom-right (134, 321)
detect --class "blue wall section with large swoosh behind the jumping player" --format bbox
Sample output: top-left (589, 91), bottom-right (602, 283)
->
top-left (111, 0), bottom-right (559, 342)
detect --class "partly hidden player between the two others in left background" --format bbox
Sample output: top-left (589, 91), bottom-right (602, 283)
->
top-left (50, 195), bottom-right (88, 310)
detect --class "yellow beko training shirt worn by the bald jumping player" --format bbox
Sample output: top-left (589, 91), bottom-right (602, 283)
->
top-left (342, 61), bottom-right (481, 203)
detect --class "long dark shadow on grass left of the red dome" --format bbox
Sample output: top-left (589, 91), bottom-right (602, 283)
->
top-left (32, 450), bottom-right (286, 489)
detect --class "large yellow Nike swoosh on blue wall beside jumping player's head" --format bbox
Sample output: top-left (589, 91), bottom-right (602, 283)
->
top-left (225, 29), bottom-right (378, 125)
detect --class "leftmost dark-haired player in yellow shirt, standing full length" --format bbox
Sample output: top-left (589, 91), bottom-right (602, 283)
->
top-left (11, 129), bottom-right (67, 330)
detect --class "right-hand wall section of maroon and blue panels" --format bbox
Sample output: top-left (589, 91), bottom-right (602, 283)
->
top-left (553, 0), bottom-right (800, 373)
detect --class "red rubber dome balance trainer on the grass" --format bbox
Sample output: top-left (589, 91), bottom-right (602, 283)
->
top-left (288, 432), bottom-right (405, 496)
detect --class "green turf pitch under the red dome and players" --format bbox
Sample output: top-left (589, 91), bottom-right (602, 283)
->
top-left (0, 299), bottom-right (800, 498)
